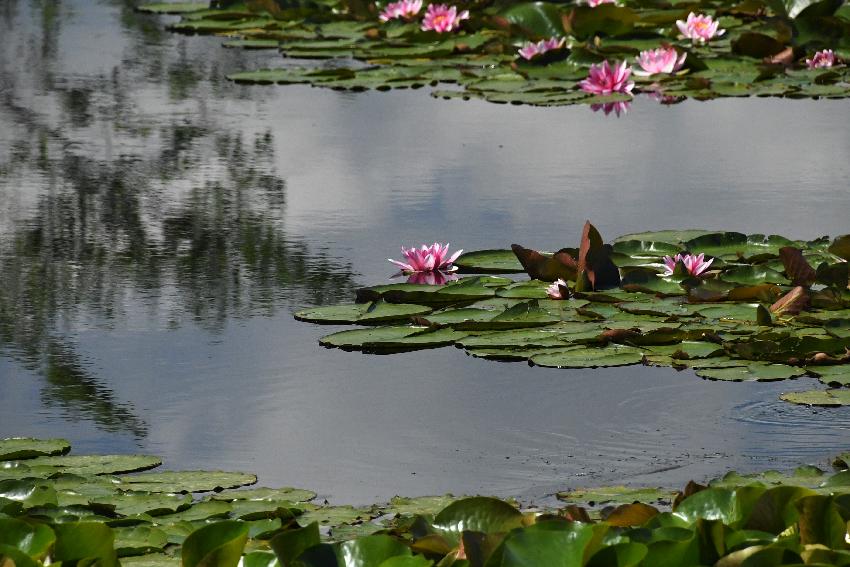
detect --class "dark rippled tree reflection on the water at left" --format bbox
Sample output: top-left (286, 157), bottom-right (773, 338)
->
top-left (0, 2), bottom-right (354, 439)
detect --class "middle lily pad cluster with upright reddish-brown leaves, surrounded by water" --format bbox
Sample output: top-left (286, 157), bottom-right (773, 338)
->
top-left (295, 223), bottom-right (850, 406)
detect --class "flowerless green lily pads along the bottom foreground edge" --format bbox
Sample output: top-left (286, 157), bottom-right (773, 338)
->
top-left (6, 438), bottom-right (850, 567)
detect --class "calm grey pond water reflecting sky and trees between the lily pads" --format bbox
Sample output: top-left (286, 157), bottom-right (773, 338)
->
top-left (0, 0), bottom-right (850, 503)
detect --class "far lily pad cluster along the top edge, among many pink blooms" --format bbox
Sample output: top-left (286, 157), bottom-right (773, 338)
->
top-left (140, 0), bottom-right (850, 105)
